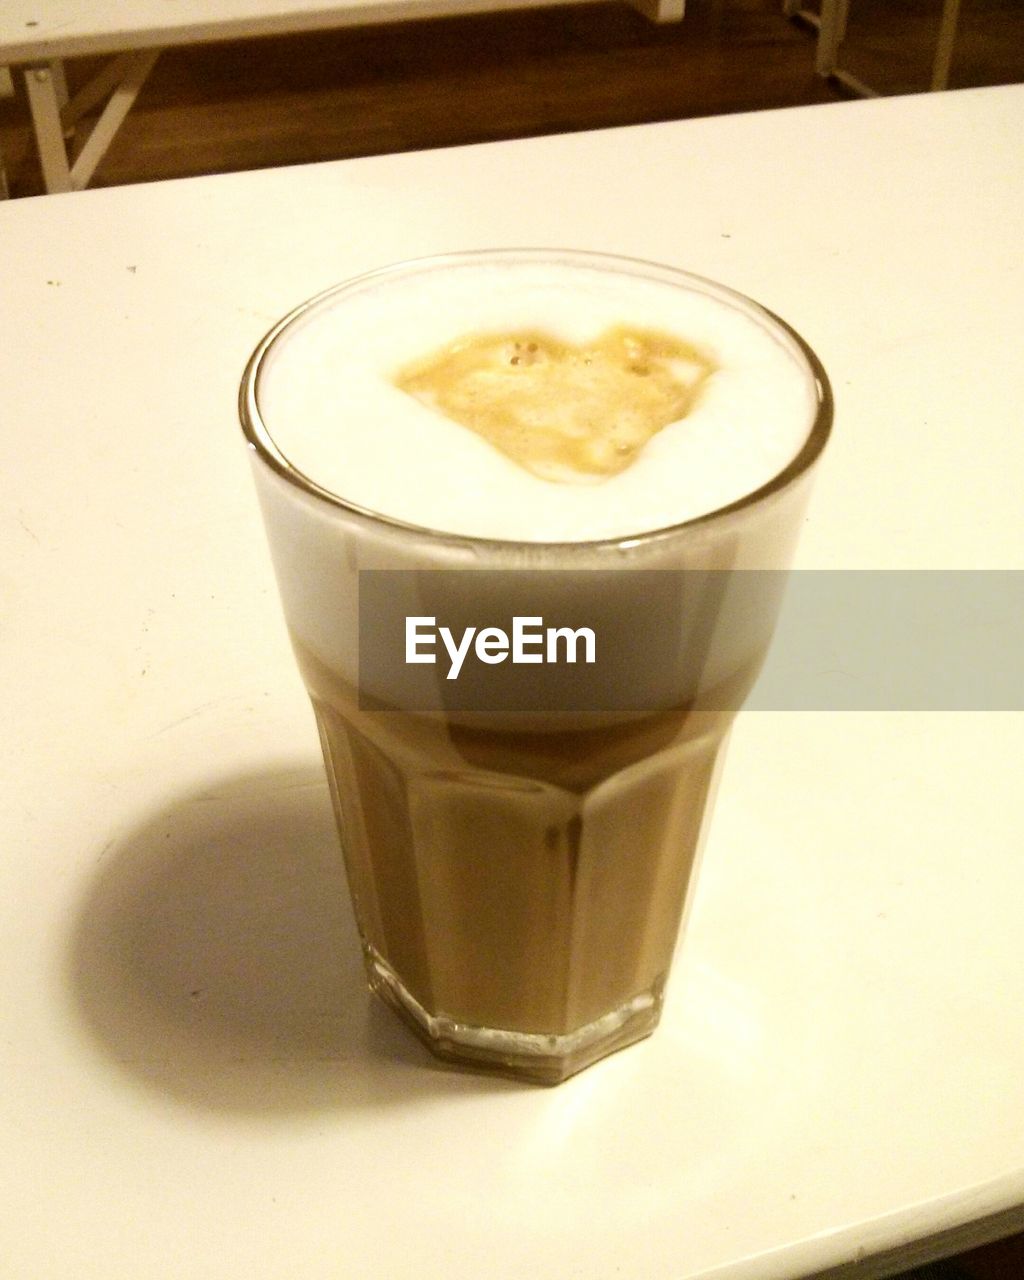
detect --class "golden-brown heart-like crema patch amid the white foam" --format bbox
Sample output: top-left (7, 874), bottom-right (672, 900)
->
top-left (396, 325), bottom-right (714, 483)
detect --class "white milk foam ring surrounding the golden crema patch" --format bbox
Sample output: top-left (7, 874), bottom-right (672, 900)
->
top-left (259, 260), bottom-right (817, 543)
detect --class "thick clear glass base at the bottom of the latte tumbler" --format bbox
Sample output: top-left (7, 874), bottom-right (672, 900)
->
top-left (364, 946), bottom-right (663, 1084)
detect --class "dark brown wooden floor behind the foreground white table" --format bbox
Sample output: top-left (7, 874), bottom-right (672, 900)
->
top-left (0, 0), bottom-right (1024, 1280)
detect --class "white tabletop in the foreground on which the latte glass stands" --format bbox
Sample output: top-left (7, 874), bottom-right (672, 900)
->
top-left (0, 87), bottom-right (1024, 1280)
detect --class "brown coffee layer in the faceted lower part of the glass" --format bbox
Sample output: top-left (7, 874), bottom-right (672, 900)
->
top-left (293, 637), bottom-right (731, 1039)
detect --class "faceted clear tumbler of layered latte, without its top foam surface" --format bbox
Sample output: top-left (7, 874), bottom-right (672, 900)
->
top-left (241, 250), bottom-right (832, 1083)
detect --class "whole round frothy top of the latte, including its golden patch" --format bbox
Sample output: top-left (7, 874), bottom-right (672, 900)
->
top-left (259, 252), bottom-right (817, 543)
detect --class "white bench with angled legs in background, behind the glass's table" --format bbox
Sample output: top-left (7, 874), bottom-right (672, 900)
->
top-left (0, 0), bottom-right (684, 193)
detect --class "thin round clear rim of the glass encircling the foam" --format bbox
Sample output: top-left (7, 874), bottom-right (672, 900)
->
top-left (238, 247), bottom-right (833, 553)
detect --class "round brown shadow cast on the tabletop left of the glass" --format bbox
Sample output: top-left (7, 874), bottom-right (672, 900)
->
top-left (67, 767), bottom-right (519, 1114)
